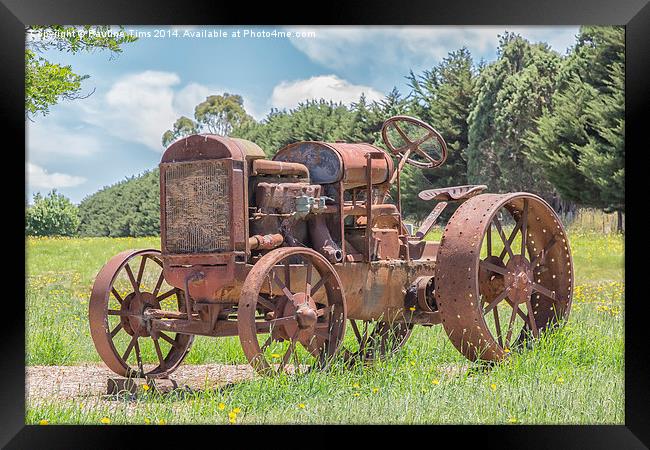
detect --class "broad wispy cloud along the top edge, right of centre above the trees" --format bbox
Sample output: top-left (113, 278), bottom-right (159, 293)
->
top-left (288, 26), bottom-right (578, 71)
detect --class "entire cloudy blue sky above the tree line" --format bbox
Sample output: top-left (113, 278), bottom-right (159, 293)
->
top-left (26, 26), bottom-right (578, 203)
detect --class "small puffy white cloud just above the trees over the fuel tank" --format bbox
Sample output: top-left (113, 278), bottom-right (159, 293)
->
top-left (271, 75), bottom-right (384, 109)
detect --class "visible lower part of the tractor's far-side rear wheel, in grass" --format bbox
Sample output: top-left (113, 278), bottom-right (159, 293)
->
top-left (344, 320), bottom-right (413, 363)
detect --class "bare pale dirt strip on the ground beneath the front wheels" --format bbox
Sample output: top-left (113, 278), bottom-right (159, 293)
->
top-left (25, 364), bottom-right (255, 403)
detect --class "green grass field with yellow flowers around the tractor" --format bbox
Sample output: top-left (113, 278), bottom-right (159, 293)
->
top-left (26, 231), bottom-right (624, 424)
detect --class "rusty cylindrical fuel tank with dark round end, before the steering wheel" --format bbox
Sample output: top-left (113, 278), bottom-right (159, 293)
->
top-left (273, 141), bottom-right (393, 189)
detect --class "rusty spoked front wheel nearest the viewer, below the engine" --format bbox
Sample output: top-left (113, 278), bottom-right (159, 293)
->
top-left (237, 247), bottom-right (347, 375)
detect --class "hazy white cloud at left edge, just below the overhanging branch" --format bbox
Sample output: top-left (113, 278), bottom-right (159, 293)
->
top-left (27, 120), bottom-right (102, 161)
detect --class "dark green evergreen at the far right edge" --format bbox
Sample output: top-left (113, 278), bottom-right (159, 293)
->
top-left (525, 26), bottom-right (625, 230)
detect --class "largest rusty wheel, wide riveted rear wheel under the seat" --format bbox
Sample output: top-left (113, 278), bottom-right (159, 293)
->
top-left (435, 193), bottom-right (573, 361)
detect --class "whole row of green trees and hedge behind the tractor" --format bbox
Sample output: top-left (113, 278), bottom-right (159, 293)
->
top-left (26, 26), bottom-right (625, 236)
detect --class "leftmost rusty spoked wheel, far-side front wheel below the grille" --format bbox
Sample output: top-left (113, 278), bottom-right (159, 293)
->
top-left (89, 250), bottom-right (193, 378)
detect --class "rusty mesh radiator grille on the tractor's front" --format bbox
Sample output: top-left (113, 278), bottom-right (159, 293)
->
top-left (165, 160), bottom-right (232, 253)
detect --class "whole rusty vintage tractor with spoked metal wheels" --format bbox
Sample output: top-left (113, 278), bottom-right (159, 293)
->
top-left (89, 116), bottom-right (573, 378)
